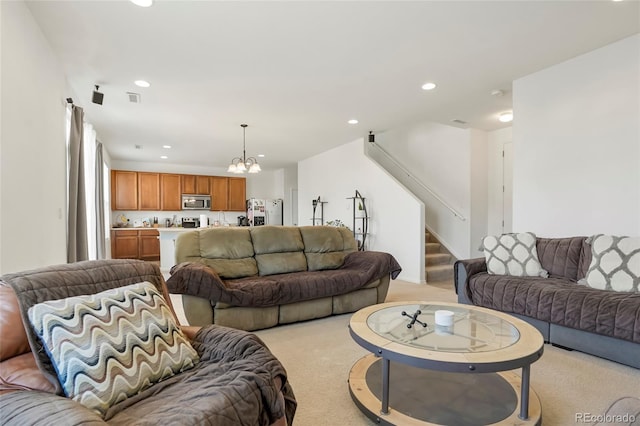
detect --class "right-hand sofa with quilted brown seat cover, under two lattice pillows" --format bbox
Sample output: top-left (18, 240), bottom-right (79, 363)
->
top-left (454, 237), bottom-right (640, 368)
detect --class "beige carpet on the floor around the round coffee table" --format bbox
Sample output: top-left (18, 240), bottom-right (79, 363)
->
top-left (256, 281), bottom-right (640, 426)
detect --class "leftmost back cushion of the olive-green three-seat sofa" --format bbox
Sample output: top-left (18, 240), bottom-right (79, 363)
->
top-left (176, 227), bottom-right (258, 279)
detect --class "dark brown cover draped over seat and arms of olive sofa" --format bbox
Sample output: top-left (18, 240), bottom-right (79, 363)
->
top-left (167, 251), bottom-right (402, 307)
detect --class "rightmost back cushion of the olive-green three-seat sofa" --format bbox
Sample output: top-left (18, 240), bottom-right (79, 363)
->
top-left (300, 226), bottom-right (357, 271)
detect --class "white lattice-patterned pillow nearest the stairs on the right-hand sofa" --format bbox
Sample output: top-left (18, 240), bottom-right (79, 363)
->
top-left (480, 232), bottom-right (549, 278)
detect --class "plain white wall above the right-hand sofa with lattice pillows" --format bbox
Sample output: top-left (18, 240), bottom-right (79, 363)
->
top-left (513, 35), bottom-right (640, 237)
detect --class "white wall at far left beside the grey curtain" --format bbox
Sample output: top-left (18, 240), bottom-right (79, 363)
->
top-left (0, 1), bottom-right (69, 274)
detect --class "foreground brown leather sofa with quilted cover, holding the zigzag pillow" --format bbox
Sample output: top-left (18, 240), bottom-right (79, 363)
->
top-left (0, 260), bottom-right (296, 426)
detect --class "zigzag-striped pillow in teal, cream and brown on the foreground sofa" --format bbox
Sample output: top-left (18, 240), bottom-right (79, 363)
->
top-left (28, 282), bottom-right (199, 418)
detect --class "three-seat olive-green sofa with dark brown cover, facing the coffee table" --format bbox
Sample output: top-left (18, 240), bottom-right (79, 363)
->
top-left (167, 226), bottom-right (401, 330)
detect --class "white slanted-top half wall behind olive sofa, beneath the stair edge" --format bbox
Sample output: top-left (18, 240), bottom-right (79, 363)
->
top-left (298, 139), bottom-right (424, 283)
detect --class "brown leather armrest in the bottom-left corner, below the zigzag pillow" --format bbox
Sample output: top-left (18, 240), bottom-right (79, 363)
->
top-left (0, 391), bottom-right (107, 426)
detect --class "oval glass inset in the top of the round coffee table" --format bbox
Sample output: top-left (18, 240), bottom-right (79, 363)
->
top-left (367, 304), bottom-right (520, 353)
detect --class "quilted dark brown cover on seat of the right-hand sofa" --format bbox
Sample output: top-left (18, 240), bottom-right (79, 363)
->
top-left (468, 273), bottom-right (640, 343)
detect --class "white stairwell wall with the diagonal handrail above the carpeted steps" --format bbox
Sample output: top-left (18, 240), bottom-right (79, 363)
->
top-left (368, 121), bottom-right (487, 259)
